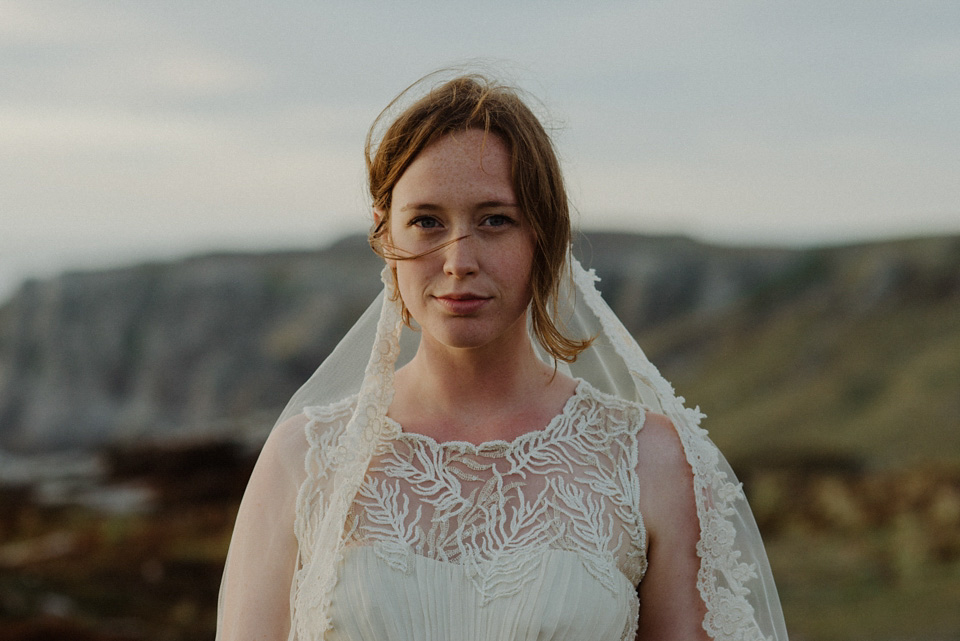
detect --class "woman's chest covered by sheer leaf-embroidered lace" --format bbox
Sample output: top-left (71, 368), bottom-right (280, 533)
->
top-left (346, 425), bottom-right (645, 590)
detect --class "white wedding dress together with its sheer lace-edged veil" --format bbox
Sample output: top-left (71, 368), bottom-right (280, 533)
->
top-left (217, 258), bottom-right (787, 641)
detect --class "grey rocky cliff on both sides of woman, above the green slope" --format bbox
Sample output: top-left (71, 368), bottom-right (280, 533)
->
top-left (0, 234), bottom-right (960, 450)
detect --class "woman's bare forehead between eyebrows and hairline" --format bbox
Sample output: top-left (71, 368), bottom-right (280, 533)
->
top-left (393, 129), bottom-right (514, 206)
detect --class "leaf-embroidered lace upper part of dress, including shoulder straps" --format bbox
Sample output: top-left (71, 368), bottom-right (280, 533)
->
top-left (296, 381), bottom-right (646, 638)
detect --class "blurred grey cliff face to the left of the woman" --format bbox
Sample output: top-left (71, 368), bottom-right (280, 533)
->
top-left (0, 235), bottom-right (379, 450)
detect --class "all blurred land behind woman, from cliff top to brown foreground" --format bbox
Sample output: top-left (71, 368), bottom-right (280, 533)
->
top-left (0, 234), bottom-right (960, 641)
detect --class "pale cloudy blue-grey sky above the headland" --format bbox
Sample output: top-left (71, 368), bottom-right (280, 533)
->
top-left (0, 0), bottom-right (960, 298)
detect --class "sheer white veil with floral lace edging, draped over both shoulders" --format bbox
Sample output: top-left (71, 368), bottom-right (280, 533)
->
top-left (217, 257), bottom-right (787, 641)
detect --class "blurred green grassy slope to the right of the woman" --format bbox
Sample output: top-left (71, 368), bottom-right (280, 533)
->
top-left (642, 241), bottom-right (960, 467)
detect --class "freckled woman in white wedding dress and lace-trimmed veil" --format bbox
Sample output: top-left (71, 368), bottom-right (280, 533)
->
top-left (218, 76), bottom-right (786, 641)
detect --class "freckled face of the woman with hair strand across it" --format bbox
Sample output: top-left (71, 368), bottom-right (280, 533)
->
top-left (388, 129), bottom-right (534, 348)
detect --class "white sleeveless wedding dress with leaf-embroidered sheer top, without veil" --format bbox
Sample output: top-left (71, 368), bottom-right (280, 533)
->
top-left (296, 381), bottom-right (646, 641)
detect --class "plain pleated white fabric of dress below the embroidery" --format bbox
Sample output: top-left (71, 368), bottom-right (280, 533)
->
top-left (325, 546), bottom-right (637, 641)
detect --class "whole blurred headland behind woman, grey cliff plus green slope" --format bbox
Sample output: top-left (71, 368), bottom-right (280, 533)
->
top-left (0, 233), bottom-right (960, 458)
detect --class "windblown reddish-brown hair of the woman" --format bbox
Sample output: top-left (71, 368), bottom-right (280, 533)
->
top-left (365, 74), bottom-right (592, 363)
